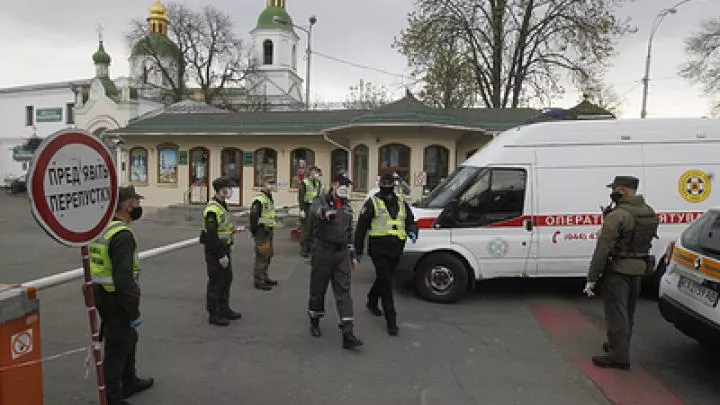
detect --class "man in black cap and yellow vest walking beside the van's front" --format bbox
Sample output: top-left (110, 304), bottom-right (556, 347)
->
top-left (355, 174), bottom-right (417, 336)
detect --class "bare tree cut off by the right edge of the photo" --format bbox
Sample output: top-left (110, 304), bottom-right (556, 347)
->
top-left (680, 17), bottom-right (720, 116)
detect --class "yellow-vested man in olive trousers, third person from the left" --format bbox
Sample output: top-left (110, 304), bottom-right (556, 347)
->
top-left (250, 180), bottom-right (278, 291)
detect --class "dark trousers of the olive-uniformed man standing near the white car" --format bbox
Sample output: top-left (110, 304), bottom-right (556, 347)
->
top-left (602, 271), bottom-right (641, 363)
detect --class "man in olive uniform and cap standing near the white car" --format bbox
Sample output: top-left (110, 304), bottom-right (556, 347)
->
top-left (583, 176), bottom-right (659, 370)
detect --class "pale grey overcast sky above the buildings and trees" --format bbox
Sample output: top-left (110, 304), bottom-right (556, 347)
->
top-left (0, 0), bottom-right (720, 118)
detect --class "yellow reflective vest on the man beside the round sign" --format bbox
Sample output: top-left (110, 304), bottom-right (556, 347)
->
top-left (88, 220), bottom-right (140, 292)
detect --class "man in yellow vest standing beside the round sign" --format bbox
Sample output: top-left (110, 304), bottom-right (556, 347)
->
top-left (88, 186), bottom-right (154, 405)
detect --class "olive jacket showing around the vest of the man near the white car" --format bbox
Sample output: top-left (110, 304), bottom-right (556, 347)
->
top-left (587, 195), bottom-right (654, 282)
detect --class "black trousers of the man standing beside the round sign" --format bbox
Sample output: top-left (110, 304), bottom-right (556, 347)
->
top-left (97, 295), bottom-right (138, 404)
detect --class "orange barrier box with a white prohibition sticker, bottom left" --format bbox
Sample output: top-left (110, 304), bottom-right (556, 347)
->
top-left (0, 284), bottom-right (43, 405)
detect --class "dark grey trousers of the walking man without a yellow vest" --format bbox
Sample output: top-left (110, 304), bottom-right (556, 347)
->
top-left (308, 241), bottom-right (354, 326)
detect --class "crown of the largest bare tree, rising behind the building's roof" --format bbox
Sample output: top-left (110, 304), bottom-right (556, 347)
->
top-left (396, 0), bottom-right (630, 108)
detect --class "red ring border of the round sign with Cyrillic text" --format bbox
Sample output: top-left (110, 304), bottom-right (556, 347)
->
top-left (27, 129), bottom-right (118, 247)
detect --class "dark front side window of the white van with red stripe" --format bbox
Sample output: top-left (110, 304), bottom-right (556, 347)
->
top-left (458, 168), bottom-right (527, 226)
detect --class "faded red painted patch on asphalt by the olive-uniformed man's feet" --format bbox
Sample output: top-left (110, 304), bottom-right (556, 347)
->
top-left (531, 304), bottom-right (684, 405)
